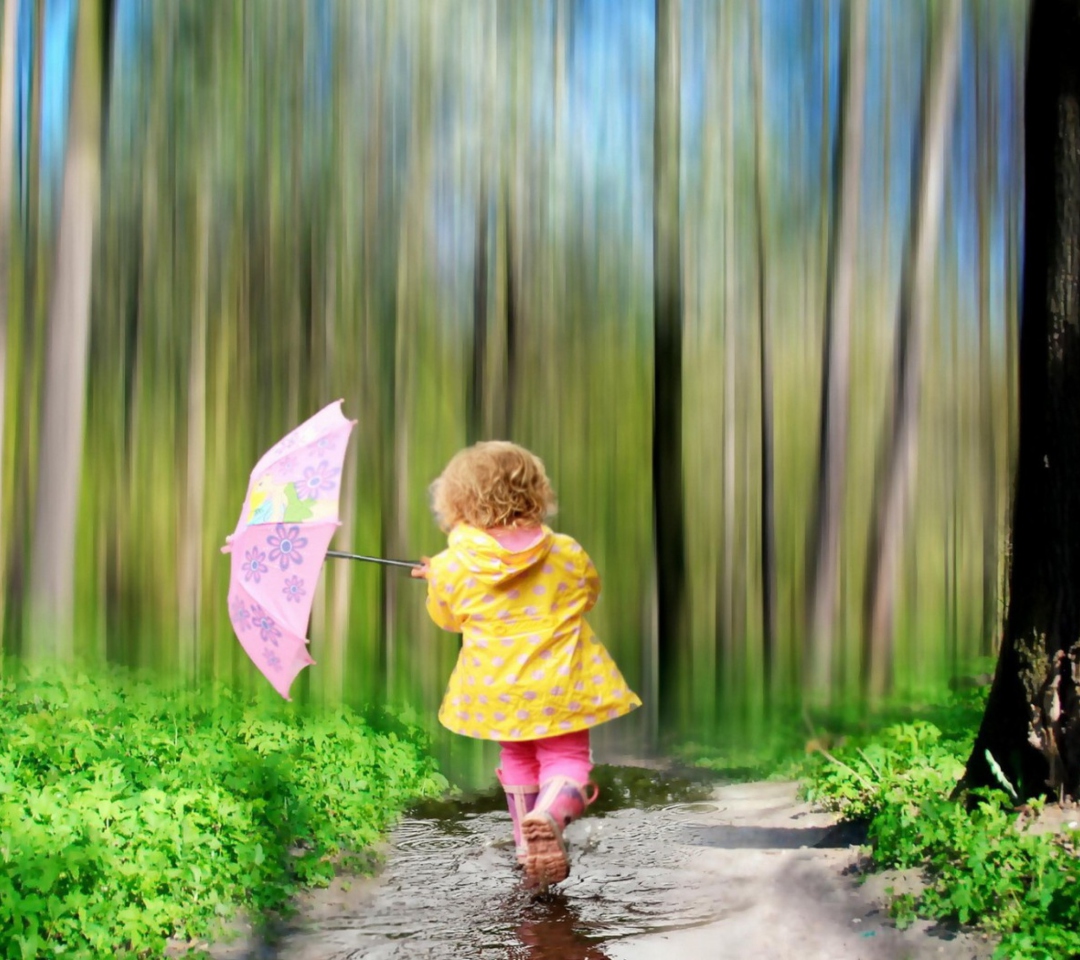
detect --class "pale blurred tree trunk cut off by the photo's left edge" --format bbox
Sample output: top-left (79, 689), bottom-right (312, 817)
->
top-left (0, 0), bottom-right (22, 650)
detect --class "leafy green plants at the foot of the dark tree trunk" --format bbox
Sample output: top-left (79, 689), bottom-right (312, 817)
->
top-left (806, 695), bottom-right (1080, 960)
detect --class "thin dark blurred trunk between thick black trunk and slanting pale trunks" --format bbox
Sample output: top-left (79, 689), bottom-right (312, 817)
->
top-left (752, 3), bottom-right (779, 693)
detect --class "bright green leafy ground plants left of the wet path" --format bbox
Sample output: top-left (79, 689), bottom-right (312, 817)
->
top-left (0, 670), bottom-right (446, 958)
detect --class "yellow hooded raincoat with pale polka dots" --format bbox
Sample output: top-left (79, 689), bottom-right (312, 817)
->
top-left (428, 524), bottom-right (642, 741)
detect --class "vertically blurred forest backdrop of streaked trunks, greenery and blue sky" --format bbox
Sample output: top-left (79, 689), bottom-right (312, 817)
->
top-left (0, 0), bottom-right (1027, 764)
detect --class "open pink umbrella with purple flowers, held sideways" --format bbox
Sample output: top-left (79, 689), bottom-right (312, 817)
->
top-left (221, 401), bottom-right (415, 700)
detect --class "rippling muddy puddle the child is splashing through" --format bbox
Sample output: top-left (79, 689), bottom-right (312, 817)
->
top-left (260, 767), bottom-right (723, 960)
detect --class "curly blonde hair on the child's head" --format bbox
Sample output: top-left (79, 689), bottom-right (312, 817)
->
top-left (431, 441), bottom-right (555, 531)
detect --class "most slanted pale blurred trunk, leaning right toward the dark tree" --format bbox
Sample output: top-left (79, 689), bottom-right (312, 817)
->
top-left (863, 0), bottom-right (962, 699)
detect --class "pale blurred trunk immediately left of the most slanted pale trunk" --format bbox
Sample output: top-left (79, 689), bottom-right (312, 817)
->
top-left (806, 0), bottom-right (867, 701)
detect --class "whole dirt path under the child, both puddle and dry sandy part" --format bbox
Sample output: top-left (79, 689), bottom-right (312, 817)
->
top-left (206, 783), bottom-right (991, 960)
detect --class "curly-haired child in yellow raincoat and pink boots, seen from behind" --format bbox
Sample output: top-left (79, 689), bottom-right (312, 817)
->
top-left (413, 441), bottom-right (642, 887)
